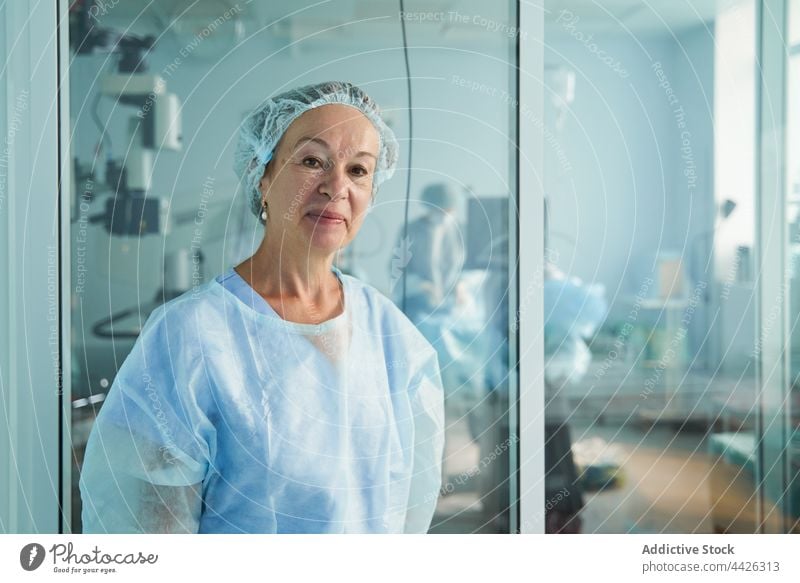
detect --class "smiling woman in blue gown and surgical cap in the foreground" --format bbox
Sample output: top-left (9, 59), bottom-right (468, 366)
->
top-left (81, 83), bottom-right (444, 533)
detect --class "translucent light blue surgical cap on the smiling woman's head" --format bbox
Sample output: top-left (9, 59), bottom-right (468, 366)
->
top-left (234, 81), bottom-right (398, 225)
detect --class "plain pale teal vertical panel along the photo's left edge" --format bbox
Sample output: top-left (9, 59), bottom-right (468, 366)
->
top-left (0, 2), bottom-right (63, 534)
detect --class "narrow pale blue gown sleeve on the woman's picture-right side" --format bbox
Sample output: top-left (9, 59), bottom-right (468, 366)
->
top-left (404, 352), bottom-right (444, 534)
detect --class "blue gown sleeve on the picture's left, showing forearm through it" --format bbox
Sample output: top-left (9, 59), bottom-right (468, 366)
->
top-left (80, 307), bottom-right (214, 533)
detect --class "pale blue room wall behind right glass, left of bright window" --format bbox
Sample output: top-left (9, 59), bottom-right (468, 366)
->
top-left (545, 26), bottom-right (714, 330)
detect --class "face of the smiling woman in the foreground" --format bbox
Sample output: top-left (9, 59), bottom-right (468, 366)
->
top-left (260, 104), bottom-right (379, 254)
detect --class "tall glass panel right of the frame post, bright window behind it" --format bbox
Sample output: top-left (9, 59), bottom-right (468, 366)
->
top-left (544, 0), bottom-right (760, 533)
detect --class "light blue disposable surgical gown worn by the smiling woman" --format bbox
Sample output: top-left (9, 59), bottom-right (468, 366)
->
top-left (80, 269), bottom-right (444, 533)
